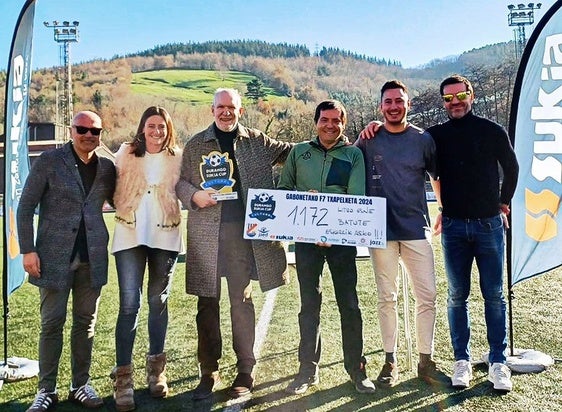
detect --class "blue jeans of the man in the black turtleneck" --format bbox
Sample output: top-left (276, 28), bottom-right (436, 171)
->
top-left (441, 215), bottom-right (507, 363)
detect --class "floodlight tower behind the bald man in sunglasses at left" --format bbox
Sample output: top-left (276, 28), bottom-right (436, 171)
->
top-left (43, 20), bottom-right (80, 140)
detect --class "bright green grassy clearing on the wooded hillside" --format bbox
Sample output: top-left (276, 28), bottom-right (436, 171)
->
top-left (131, 70), bottom-right (279, 105)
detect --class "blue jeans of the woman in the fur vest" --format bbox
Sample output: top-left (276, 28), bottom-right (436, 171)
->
top-left (115, 246), bottom-right (178, 366)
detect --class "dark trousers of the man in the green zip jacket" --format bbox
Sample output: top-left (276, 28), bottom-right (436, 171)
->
top-left (295, 243), bottom-right (365, 376)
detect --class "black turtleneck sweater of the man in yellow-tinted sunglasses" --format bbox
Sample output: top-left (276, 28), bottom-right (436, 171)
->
top-left (427, 112), bottom-right (519, 219)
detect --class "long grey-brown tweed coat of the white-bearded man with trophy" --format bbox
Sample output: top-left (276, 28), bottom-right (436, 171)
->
top-left (176, 124), bottom-right (292, 297)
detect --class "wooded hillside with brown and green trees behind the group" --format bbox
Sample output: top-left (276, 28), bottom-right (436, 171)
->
top-left (0, 40), bottom-right (518, 149)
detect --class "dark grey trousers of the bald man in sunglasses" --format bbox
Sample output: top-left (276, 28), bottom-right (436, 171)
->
top-left (39, 263), bottom-right (101, 392)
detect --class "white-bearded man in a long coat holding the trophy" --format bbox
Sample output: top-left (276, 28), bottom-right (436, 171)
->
top-left (176, 89), bottom-right (291, 400)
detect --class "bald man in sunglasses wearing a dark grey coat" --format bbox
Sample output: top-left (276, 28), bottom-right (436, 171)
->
top-left (17, 111), bottom-right (115, 412)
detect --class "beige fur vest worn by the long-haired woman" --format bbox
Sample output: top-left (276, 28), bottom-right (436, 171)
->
top-left (113, 143), bottom-right (182, 230)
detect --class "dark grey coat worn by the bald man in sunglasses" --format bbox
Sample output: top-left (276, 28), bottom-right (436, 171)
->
top-left (17, 143), bottom-right (115, 290)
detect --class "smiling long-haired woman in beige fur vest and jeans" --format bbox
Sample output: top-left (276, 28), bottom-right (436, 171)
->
top-left (111, 106), bottom-right (184, 411)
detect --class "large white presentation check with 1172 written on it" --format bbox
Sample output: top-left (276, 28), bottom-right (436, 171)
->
top-left (244, 189), bottom-right (386, 248)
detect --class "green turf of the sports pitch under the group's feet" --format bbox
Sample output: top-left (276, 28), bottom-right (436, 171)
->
top-left (0, 205), bottom-right (562, 412)
